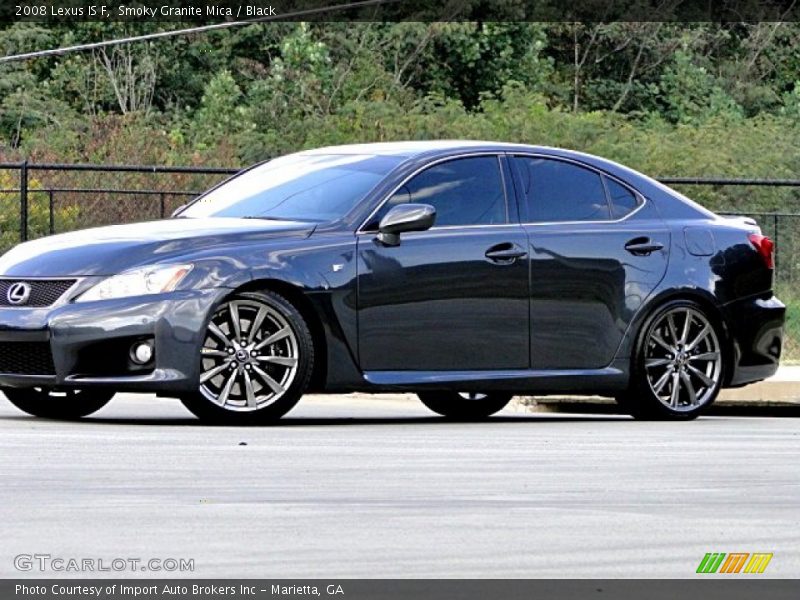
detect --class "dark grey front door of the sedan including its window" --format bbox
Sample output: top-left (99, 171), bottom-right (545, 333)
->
top-left (358, 155), bottom-right (530, 371)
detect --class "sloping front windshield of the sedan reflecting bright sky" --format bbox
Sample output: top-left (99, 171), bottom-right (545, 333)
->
top-left (180, 154), bottom-right (402, 222)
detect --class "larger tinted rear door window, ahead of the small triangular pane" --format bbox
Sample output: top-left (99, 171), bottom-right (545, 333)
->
top-left (515, 157), bottom-right (609, 223)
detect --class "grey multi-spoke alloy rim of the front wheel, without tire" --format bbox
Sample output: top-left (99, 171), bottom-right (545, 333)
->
top-left (200, 298), bottom-right (299, 412)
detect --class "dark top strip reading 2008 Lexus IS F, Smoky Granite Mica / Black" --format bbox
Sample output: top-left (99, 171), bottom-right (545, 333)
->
top-left (0, 0), bottom-right (800, 24)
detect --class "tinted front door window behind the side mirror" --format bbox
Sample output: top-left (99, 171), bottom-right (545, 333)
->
top-left (371, 156), bottom-right (508, 228)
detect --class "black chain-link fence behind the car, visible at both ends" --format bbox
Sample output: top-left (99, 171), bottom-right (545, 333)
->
top-left (0, 162), bottom-right (800, 363)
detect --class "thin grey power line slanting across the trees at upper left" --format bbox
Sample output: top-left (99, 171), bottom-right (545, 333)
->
top-left (0, 0), bottom-right (402, 63)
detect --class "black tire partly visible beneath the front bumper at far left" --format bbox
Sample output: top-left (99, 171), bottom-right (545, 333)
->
top-left (3, 388), bottom-right (114, 421)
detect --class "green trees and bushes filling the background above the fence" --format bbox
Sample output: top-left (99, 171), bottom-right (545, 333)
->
top-left (0, 22), bottom-right (800, 213)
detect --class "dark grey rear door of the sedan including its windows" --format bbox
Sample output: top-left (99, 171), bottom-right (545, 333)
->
top-left (511, 155), bottom-right (670, 369)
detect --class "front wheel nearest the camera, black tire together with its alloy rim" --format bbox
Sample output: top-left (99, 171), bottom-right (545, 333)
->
top-left (181, 291), bottom-right (314, 425)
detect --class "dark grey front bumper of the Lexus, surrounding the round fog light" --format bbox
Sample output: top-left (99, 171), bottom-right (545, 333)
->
top-left (0, 289), bottom-right (230, 394)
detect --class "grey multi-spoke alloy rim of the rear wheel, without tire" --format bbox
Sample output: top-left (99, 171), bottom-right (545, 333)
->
top-left (644, 306), bottom-right (722, 412)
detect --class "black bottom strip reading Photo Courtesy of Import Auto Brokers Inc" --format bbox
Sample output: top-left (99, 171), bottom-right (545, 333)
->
top-left (0, 576), bottom-right (800, 600)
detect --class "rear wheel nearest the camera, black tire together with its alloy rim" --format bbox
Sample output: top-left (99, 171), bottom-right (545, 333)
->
top-left (616, 300), bottom-right (726, 421)
